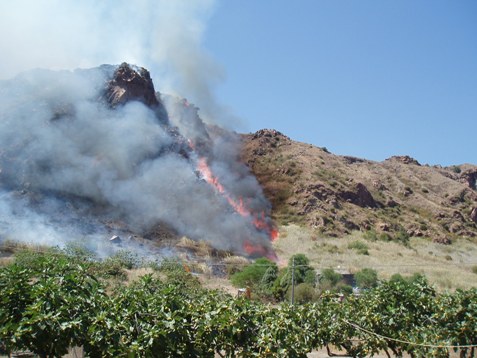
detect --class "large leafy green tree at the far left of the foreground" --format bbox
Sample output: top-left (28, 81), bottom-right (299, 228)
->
top-left (0, 258), bottom-right (104, 357)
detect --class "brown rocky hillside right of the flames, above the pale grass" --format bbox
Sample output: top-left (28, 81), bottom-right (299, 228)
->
top-left (242, 130), bottom-right (477, 243)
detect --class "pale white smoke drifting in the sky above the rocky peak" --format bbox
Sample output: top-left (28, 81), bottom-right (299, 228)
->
top-left (0, 0), bottom-right (231, 125)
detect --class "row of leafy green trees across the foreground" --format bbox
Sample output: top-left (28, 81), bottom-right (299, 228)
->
top-left (0, 246), bottom-right (477, 357)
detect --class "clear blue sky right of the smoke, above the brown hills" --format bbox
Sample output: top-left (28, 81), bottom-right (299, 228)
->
top-left (204, 0), bottom-right (477, 165)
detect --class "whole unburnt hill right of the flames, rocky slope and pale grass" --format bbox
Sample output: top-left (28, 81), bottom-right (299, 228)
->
top-left (242, 130), bottom-right (477, 290)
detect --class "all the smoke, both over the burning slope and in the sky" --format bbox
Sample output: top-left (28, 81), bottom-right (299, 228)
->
top-left (0, 0), bottom-right (269, 258)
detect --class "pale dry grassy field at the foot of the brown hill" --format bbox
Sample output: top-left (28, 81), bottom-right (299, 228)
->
top-left (274, 225), bottom-right (477, 290)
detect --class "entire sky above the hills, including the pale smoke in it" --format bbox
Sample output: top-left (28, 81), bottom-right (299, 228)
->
top-left (0, 0), bottom-right (477, 166)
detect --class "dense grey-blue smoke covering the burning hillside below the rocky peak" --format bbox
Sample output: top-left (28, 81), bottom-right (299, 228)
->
top-left (0, 68), bottom-right (269, 252)
